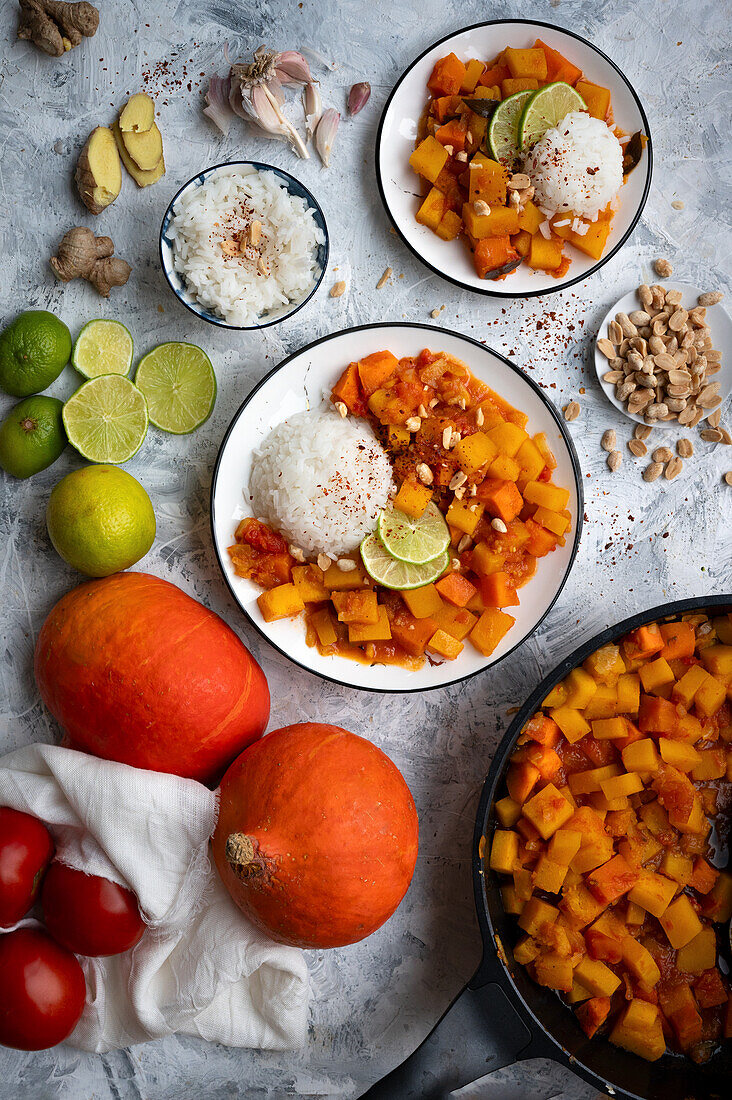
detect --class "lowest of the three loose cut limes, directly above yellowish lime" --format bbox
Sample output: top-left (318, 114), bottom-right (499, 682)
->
top-left (63, 374), bottom-right (148, 464)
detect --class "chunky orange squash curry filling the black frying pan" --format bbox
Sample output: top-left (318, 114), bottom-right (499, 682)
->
top-left (490, 614), bottom-right (732, 1063)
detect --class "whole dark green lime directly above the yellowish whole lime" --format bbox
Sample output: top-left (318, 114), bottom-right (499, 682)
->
top-left (0, 395), bottom-right (68, 477)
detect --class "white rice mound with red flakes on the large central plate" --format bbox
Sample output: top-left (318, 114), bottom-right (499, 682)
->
top-left (249, 411), bottom-right (392, 558)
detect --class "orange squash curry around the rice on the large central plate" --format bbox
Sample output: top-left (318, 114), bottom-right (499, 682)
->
top-left (229, 350), bottom-right (571, 669)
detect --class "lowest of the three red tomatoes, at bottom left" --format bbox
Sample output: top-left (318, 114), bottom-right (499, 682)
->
top-left (0, 928), bottom-right (86, 1051)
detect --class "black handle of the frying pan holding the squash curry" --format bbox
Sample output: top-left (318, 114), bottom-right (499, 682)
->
top-left (362, 971), bottom-right (548, 1100)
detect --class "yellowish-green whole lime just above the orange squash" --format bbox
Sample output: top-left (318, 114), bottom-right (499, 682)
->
top-left (46, 465), bottom-right (155, 576)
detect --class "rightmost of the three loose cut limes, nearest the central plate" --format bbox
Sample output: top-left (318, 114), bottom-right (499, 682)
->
top-left (134, 343), bottom-right (216, 436)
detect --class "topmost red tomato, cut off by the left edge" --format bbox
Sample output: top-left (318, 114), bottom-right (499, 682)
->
top-left (0, 806), bottom-right (54, 928)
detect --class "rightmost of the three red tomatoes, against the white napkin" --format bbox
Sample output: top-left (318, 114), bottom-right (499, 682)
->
top-left (41, 861), bottom-right (145, 955)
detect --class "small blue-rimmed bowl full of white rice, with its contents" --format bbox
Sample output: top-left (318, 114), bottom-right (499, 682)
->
top-left (160, 161), bottom-right (328, 329)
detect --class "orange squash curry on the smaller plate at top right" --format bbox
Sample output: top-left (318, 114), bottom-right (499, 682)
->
top-left (409, 39), bottom-right (625, 279)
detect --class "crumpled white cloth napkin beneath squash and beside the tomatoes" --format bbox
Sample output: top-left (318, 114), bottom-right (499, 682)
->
top-left (0, 745), bottom-right (309, 1053)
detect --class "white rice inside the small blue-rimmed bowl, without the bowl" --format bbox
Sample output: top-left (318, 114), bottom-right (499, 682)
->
top-left (170, 167), bottom-right (324, 326)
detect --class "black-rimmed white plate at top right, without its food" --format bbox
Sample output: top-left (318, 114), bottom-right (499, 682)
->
top-left (376, 20), bottom-right (653, 298)
